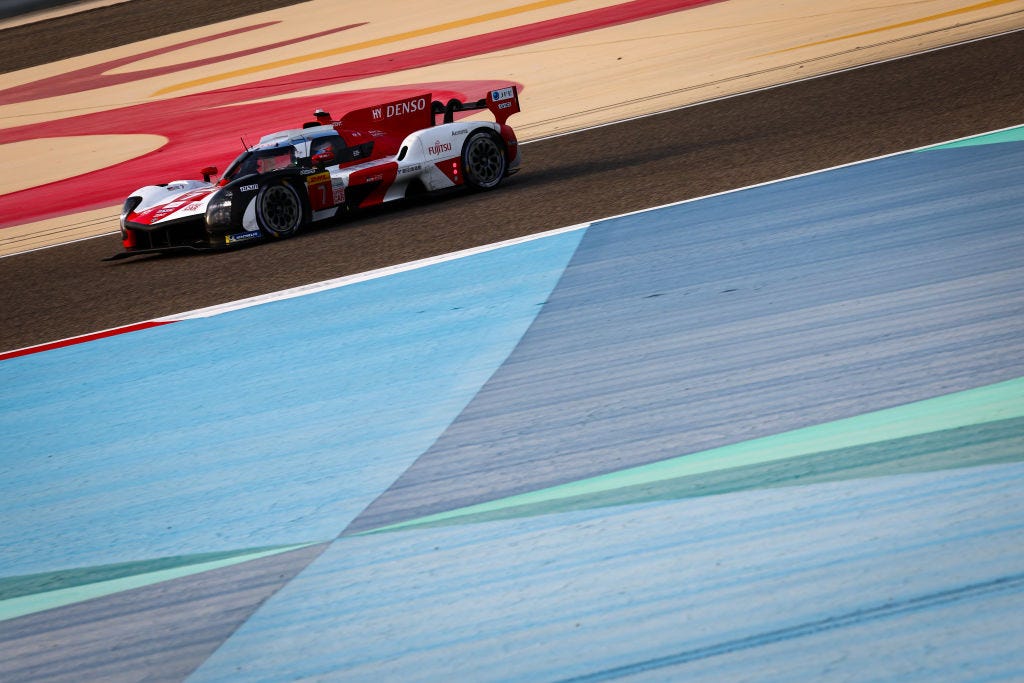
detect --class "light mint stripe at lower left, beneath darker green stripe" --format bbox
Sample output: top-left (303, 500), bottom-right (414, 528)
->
top-left (0, 543), bottom-right (315, 622)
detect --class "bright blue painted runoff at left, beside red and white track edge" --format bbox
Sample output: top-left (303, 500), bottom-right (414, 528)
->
top-left (0, 230), bottom-right (584, 575)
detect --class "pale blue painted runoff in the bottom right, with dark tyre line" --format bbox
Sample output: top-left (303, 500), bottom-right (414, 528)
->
top-left (188, 463), bottom-right (1024, 683)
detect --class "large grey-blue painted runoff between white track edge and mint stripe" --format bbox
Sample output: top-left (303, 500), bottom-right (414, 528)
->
top-left (351, 141), bottom-right (1024, 530)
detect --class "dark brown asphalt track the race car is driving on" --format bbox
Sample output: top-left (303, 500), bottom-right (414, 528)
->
top-left (0, 10), bottom-right (1024, 350)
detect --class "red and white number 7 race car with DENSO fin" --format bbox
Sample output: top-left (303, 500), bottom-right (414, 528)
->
top-left (114, 86), bottom-right (519, 258)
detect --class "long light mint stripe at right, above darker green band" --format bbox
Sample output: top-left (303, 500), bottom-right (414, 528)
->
top-left (364, 378), bottom-right (1024, 533)
